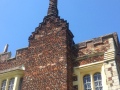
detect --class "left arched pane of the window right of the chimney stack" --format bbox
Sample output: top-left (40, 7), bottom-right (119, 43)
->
top-left (83, 75), bottom-right (91, 90)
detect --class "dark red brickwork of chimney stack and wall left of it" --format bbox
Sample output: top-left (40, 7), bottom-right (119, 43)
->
top-left (0, 12), bottom-right (73, 90)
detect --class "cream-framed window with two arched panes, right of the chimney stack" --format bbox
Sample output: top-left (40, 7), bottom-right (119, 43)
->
top-left (73, 61), bottom-right (108, 90)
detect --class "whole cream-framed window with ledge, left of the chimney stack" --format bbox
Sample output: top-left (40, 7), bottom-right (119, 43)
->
top-left (0, 65), bottom-right (25, 90)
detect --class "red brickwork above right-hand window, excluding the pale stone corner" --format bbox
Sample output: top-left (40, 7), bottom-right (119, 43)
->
top-left (74, 37), bottom-right (110, 66)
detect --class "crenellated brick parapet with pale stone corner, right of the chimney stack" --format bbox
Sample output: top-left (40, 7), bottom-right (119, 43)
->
top-left (74, 33), bottom-right (117, 65)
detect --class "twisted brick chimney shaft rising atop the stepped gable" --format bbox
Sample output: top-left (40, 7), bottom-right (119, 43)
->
top-left (48, 0), bottom-right (58, 16)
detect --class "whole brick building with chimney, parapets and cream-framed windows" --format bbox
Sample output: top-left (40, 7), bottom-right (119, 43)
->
top-left (0, 0), bottom-right (120, 90)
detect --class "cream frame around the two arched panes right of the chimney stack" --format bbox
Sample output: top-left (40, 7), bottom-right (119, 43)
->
top-left (73, 61), bottom-right (108, 90)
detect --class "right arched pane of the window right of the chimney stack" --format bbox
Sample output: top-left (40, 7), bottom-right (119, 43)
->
top-left (94, 73), bottom-right (103, 90)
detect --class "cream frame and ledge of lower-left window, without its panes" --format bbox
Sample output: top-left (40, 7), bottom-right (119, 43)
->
top-left (0, 66), bottom-right (25, 90)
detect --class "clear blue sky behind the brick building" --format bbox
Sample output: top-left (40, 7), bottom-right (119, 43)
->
top-left (0, 0), bottom-right (120, 57)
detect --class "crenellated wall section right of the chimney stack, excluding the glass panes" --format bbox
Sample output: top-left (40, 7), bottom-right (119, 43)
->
top-left (73, 33), bottom-right (120, 90)
